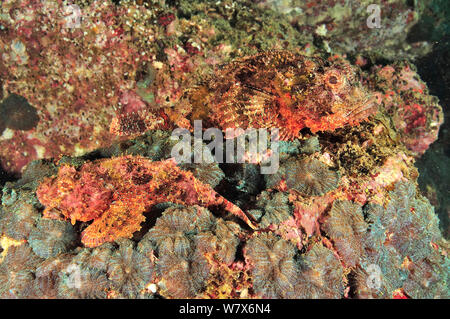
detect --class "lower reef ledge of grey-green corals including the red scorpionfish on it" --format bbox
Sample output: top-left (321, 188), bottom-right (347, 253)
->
top-left (0, 118), bottom-right (449, 298)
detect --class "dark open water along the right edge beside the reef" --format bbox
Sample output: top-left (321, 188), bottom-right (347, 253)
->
top-left (408, 0), bottom-right (450, 238)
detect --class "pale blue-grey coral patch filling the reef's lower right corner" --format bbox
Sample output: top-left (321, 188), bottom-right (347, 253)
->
top-left (355, 182), bottom-right (449, 298)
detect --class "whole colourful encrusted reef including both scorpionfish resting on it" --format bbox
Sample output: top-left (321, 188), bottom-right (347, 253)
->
top-left (0, 0), bottom-right (450, 298)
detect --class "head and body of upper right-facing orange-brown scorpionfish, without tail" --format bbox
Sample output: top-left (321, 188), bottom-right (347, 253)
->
top-left (188, 51), bottom-right (376, 140)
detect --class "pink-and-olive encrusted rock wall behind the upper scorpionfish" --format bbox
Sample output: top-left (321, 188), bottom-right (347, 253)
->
top-left (0, 0), bottom-right (439, 175)
